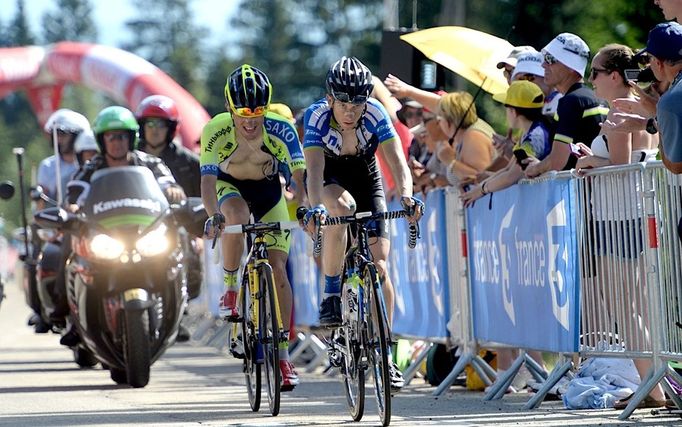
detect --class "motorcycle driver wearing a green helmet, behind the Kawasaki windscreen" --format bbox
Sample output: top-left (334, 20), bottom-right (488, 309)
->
top-left (60, 106), bottom-right (186, 347)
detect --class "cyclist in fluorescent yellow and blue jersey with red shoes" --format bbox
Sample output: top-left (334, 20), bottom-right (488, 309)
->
top-left (201, 64), bottom-right (305, 391)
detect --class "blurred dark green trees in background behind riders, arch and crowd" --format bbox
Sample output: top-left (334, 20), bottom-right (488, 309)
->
top-left (0, 0), bottom-right (664, 237)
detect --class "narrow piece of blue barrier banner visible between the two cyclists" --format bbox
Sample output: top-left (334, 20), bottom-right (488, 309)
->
top-left (288, 229), bottom-right (321, 326)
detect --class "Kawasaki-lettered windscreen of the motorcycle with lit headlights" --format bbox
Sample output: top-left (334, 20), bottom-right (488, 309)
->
top-left (83, 166), bottom-right (168, 228)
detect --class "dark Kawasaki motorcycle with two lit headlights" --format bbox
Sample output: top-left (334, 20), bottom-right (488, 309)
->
top-left (35, 166), bottom-right (206, 387)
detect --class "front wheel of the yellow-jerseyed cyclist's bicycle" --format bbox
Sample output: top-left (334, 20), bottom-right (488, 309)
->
top-left (258, 264), bottom-right (282, 416)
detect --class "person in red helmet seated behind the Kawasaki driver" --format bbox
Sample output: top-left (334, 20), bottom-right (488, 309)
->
top-left (135, 95), bottom-right (203, 342)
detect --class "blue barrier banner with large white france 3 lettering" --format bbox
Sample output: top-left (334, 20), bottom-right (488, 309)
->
top-left (467, 180), bottom-right (579, 352)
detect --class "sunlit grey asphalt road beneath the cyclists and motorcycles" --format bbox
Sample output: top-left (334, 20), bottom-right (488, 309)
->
top-left (0, 284), bottom-right (682, 427)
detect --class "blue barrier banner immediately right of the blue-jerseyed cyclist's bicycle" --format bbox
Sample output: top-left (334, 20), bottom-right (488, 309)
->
top-left (388, 190), bottom-right (450, 339)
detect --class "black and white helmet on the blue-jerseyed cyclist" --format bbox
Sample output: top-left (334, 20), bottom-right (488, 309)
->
top-left (326, 56), bottom-right (374, 103)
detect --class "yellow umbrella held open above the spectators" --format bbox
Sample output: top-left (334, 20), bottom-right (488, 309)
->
top-left (400, 26), bottom-right (514, 94)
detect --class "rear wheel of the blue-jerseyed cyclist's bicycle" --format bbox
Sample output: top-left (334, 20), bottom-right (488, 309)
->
top-left (336, 282), bottom-right (366, 421)
